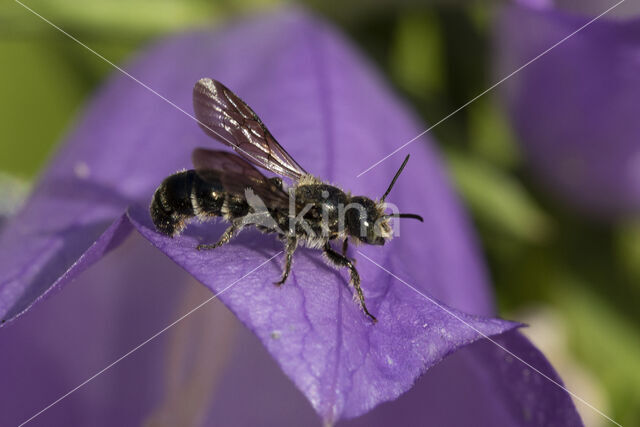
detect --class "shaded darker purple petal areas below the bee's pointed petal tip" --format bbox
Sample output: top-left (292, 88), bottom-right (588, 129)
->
top-left (0, 249), bottom-right (580, 427)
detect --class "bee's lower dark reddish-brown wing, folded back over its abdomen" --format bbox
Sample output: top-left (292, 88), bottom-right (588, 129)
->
top-left (192, 148), bottom-right (289, 209)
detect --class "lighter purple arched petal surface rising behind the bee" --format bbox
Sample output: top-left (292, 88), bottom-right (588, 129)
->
top-left (0, 13), bottom-right (492, 320)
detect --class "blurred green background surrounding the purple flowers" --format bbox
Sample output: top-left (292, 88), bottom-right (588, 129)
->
top-left (0, 0), bottom-right (640, 426)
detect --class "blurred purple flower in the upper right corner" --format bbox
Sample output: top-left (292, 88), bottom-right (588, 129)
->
top-left (497, 0), bottom-right (640, 218)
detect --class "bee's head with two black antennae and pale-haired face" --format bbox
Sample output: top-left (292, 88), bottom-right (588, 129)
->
top-left (345, 156), bottom-right (424, 245)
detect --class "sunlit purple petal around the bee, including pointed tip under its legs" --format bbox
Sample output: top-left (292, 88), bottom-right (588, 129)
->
top-left (0, 8), bottom-right (570, 426)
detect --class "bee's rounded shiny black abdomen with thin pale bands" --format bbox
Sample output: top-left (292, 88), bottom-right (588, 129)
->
top-left (150, 170), bottom-right (225, 236)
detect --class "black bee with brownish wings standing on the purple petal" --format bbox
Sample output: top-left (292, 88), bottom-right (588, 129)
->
top-left (150, 78), bottom-right (423, 323)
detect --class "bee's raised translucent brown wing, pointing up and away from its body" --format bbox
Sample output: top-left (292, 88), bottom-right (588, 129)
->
top-left (193, 78), bottom-right (306, 180)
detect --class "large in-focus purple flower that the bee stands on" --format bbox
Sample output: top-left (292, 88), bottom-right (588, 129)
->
top-left (0, 7), bottom-right (581, 425)
